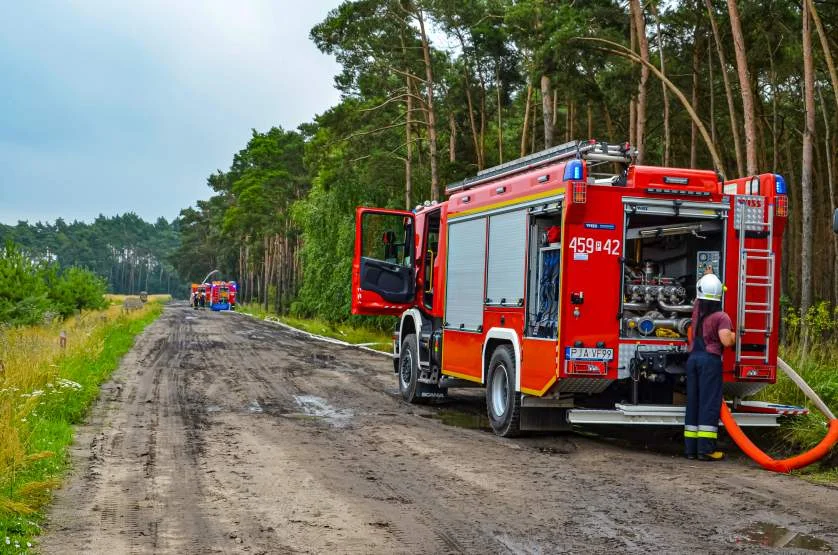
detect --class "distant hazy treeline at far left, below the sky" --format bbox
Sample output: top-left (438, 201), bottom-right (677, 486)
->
top-left (0, 213), bottom-right (186, 296)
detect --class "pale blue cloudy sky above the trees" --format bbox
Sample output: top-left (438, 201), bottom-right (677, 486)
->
top-left (0, 0), bottom-right (340, 223)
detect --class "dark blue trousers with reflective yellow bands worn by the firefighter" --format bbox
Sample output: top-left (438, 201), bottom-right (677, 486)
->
top-left (684, 352), bottom-right (722, 456)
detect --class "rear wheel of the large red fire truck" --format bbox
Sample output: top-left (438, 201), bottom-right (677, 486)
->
top-left (486, 345), bottom-right (521, 437)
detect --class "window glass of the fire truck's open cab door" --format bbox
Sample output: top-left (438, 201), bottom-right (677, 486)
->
top-left (361, 213), bottom-right (413, 267)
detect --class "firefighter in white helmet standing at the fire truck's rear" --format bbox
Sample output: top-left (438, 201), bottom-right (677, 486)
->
top-left (684, 268), bottom-right (736, 461)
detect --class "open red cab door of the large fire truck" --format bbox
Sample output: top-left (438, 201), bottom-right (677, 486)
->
top-left (352, 208), bottom-right (416, 316)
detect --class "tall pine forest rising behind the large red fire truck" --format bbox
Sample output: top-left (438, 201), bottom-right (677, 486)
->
top-left (172, 0), bottom-right (838, 326)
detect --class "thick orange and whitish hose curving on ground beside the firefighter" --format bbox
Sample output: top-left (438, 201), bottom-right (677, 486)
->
top-left (721, 358), bottom-right (838, 473)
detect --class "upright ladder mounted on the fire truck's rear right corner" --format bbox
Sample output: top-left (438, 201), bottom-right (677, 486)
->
top-left (733, 195), bottom-right (776, 365)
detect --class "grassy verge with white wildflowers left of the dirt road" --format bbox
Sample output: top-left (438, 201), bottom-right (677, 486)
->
top-left (0, 302), bottom-right (163, 553)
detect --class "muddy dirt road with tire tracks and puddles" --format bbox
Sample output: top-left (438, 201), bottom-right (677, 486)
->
top-left (42, 305), bottom-right (838, 553)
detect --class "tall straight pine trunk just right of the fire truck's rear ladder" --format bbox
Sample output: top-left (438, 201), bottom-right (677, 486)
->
top-left (800, 2), bottom-right (815, 326)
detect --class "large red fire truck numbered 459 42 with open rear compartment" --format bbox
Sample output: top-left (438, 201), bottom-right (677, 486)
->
top-left (352, 141), bottom-right (797, 436)
